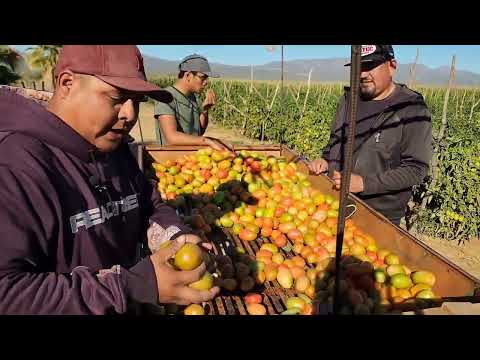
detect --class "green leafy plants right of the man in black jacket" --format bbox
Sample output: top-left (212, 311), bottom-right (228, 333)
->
top-left (414, 88), bottom-right (480, 242)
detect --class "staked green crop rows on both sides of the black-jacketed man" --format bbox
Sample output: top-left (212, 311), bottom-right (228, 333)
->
top-left (151, 77), bottom-right (480, 242)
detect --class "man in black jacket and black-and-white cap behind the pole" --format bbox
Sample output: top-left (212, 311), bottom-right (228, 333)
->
top-left (309, 45), bottom-right (432, 225)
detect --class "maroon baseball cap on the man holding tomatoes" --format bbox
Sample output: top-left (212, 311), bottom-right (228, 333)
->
top-left (55, 45), bottom-right (173, 103)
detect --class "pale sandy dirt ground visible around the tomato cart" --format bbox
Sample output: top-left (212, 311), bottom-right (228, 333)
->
top-left (131, 103), bottom-right (480, 279)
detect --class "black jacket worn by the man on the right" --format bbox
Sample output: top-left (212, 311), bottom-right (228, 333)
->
top-left (323, 84), bottom-right (432, 220)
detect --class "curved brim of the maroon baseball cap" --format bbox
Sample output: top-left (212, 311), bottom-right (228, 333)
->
top-left (95, 75), bottom-right (173, 103)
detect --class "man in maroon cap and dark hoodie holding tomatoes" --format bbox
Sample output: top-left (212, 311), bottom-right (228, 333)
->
top-left (0, 45), bottom-right (219, 314)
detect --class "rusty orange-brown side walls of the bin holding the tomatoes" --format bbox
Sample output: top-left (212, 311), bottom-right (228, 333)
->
top-left (132, 144), bottom-right (480, 312)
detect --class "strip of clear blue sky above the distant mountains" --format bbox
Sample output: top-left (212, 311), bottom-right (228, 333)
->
top-left (12, 45), bottom-right (480, 73)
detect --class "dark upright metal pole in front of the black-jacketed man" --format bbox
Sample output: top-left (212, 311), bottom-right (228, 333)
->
top-left (333, 45), bottom-right (361, 314)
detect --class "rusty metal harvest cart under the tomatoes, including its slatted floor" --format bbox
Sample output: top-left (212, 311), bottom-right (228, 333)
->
top-left (132, 144), bottom-right (480, 315)
